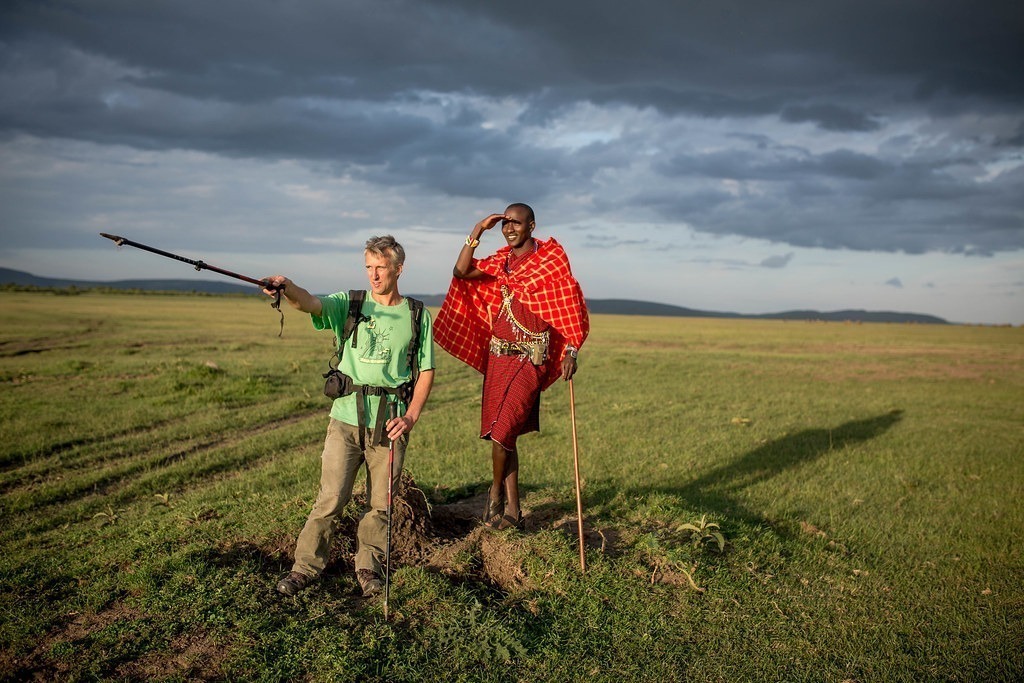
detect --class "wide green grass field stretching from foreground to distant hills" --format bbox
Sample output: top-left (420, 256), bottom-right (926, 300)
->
top-left (0, 293), bottom-right (1024, 683)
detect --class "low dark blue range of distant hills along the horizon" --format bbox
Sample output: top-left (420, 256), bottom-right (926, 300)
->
top-left (0, 268), bottom-right (948, 325)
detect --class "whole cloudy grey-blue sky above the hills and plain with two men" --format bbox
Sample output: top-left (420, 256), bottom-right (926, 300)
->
top-left (0, 0), bottom-right (1024, 325)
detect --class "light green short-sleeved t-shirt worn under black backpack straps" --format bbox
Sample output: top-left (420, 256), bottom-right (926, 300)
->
top-left (310, 292), bottom-right (434, 427)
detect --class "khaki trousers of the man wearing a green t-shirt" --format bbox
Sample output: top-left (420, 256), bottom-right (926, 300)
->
top-left (292, 418), bottom-right (408, 577)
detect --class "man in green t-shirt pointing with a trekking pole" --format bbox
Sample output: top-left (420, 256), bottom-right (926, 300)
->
top-left (264, 236), bottom-right (434, 596)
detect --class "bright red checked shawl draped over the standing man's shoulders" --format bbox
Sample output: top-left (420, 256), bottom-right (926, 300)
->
top-left (434, 238), bottom-right (590, 389)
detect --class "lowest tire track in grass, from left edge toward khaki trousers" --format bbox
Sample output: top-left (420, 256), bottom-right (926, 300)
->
top-left (2, 409), bottom-right (324, 537)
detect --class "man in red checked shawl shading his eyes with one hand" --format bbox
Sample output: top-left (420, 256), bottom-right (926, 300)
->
top-left (434, 204), bottom-right (590, 528)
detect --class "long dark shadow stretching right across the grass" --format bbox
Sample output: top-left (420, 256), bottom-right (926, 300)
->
top-left (594, 410), bottom-right (903, 526)
